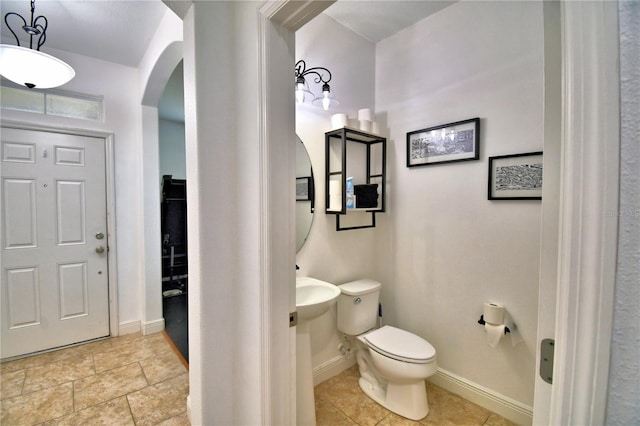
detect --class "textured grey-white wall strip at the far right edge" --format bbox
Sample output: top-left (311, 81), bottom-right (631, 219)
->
top-left (606, 2), bottom-right (640, 425)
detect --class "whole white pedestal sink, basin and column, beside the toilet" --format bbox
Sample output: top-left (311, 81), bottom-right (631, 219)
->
top-left (296, 277), bottom-right (340, 426)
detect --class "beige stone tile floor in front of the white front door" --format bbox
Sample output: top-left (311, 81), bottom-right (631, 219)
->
top-left (0, 333), bottom-right (189, 426)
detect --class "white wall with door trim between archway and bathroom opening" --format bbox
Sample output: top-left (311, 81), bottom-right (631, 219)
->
top-left (184, 2), bottom-right (297, 424)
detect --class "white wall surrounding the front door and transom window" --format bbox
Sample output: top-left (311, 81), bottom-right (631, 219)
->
top-left (2, 49), bottom-right (143, 324)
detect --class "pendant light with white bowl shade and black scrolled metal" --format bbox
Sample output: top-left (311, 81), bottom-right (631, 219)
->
top-left (0, 0), bottom-right (76, 89)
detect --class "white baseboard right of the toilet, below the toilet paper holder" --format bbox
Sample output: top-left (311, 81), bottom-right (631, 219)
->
top-left (427, 368), bottom-right (533, 425)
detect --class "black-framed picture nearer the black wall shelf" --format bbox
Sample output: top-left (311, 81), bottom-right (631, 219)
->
top-left (407, 117), bottom-right (480, 167)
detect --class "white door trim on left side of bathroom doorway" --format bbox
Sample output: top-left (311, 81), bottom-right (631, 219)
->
top-left (257, 0), bottom-right (333, 424)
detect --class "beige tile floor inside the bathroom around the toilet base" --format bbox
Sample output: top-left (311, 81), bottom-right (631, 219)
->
top-left (315, 366), bottom-right (514, 426)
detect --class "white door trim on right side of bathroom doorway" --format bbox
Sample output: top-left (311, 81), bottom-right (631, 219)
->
top-left (548, 2), bottom-right (620, 425)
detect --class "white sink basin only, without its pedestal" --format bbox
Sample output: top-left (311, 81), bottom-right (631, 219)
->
top-left (296, 277), bottom-right (340, 321)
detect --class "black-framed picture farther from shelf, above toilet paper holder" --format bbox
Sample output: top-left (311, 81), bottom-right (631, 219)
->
top-left (487, 151), bottom-right (543, 200)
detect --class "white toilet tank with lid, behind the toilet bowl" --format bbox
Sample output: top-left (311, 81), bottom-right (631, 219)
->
top-left (337, 279), bottom-right (381, 336)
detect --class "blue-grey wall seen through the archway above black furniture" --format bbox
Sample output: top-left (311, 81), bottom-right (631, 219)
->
top-left (158, 120), bottom-right (187, 179)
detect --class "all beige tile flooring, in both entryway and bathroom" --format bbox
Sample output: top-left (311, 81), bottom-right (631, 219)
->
top-left (0, 333), bottom-right (513, 426)
